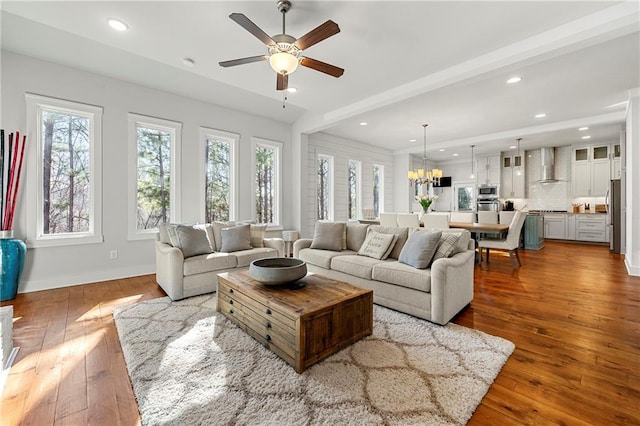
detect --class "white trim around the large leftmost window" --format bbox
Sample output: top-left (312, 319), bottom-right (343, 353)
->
top-left (23, 93), bottom-right (104, 248)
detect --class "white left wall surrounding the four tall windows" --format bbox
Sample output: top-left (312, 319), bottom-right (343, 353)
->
top-left (0, 51), bottom-right (294, 292)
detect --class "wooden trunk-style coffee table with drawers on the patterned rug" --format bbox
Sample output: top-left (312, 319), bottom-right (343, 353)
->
top-left (217, 272), bottom-right (373, 373)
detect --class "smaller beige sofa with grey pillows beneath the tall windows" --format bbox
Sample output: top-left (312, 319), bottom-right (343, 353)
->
top-left (155, 222), bottom-right (284, 300)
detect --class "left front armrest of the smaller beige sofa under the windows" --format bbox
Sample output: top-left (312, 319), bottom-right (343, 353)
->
top-left (155, 241), bottom-right (184, 300)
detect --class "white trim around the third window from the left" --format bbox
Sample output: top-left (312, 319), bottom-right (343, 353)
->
top-left (198, 127), bottom-right (239, 222)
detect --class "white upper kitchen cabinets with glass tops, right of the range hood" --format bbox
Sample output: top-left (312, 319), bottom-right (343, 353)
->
top-left (572, 144), bottom-right (613, 197)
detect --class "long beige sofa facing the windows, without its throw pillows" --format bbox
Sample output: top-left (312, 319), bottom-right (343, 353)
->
top-left (293, 223), bottom-right (475, 325)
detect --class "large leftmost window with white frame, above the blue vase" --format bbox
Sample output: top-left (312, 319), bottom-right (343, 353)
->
top-left (23, 94), bottom-right (103, 247)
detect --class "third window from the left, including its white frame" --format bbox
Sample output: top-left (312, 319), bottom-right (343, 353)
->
top-left (200, 128), bottom-right (240, 223)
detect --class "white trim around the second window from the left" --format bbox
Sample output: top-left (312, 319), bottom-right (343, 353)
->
top-left (127, 113), bottom-right (182, 240)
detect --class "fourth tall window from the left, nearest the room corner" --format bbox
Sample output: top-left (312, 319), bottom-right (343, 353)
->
top-left (254, 138), bottom-right (282, 224)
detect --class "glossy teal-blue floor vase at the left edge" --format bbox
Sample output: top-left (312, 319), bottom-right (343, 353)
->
top-left (0, 231), bottom-right (27, 301)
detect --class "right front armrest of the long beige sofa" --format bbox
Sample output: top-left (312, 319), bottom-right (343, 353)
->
top-left (431, 250), bottom-right (475, 325)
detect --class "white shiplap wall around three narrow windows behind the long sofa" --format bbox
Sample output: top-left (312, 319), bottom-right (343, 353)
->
top-left (300, 133), bottom-right (394, 237)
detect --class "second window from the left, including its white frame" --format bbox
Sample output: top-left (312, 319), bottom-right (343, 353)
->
top-left (129, 114), bottom-right (182, 239)
